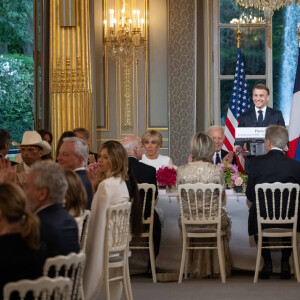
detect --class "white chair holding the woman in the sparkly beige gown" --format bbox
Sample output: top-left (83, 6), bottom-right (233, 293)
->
top-left (178, 183), bottom-right (226, 283)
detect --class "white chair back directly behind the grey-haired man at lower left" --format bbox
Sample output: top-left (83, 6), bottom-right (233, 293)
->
top-left (43, 252), bottom-right (86, 300)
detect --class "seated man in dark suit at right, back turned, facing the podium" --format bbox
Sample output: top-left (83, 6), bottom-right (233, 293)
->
top-left (246, 125), bottom-right (300, 279)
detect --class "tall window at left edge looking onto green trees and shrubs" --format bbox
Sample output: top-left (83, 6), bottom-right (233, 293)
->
top-left (0, 0), bottom-right (34, 141)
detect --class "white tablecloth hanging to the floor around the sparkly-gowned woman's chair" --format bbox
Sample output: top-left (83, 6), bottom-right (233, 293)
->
top-left (156, 190), bottom-right (290, 272)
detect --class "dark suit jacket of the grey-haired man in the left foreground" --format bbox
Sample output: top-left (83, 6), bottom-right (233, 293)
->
top-left (37, 204), bottom-right (79, 257)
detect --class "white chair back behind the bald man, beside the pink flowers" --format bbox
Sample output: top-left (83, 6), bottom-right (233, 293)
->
top-left (138, 183), bottom-right (156, 225)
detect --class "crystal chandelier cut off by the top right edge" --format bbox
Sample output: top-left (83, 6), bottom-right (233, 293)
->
top-left (236, 0), bottom-right (300, 18)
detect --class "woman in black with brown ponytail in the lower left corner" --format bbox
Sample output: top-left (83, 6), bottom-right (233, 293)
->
top-left (0, 183), bottom-right (44, 299)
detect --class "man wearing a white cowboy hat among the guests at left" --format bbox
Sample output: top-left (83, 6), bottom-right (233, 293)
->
top-left (12, 131), bottom-right (51, 185)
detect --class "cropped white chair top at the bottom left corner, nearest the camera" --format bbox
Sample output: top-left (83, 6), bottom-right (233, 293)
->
top-left (3, 277), bottom-right (72, 300)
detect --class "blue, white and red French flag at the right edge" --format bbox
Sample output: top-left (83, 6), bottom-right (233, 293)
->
top-left (287, 48), bottom-right (300, 161)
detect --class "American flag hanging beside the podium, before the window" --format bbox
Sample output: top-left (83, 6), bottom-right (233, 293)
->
top-left (223, 48), bottom-right (250, 172)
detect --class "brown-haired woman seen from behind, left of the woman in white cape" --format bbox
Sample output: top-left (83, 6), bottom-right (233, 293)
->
top-left (64, 170), bottom-right (87, 242)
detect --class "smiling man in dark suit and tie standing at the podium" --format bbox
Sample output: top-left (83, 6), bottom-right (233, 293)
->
top-left (233, 83), bottom-right (285, 173)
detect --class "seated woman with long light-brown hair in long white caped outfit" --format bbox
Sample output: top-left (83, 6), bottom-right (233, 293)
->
top-left (83, 141), bottom-right (142, 300)
